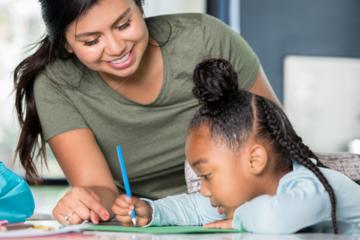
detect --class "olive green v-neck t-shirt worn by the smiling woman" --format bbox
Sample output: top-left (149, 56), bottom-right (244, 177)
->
top-left (34, 14), bottom-right (259, 199)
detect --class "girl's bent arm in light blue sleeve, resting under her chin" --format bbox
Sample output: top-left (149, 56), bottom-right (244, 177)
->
top-left (232, 178), bottom-right (331, 234)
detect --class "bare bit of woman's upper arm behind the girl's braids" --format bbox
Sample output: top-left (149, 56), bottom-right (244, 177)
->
top-left (249, 66), bottom-right (281, 106)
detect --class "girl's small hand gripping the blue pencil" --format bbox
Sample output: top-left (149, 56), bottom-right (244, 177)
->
top-left (111, 194), bottom-right (152, 226)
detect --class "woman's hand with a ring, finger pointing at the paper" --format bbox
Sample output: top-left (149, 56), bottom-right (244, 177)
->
top-left (53, 187), bottom-right (110, 225)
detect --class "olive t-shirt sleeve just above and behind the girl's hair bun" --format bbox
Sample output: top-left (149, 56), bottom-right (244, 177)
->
top-left (202, 15), bottom-right (260, 90)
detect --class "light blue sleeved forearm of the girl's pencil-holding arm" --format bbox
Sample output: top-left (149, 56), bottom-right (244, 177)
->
top-left (148, 193), bottom-right (225, 226)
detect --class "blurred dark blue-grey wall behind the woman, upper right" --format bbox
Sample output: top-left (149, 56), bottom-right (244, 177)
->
top-left (240, 0), bottom-right (360, 102)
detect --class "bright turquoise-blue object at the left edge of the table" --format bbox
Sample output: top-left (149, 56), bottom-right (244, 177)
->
top-left (0, 162), bottom-right (35, 223)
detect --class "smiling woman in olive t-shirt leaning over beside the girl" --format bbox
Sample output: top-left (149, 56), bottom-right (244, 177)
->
top-left (14, 0), bottom-right (277, 224)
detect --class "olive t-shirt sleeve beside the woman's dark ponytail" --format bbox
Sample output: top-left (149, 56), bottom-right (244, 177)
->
top-left (34, 74), bottom-right (88, 141)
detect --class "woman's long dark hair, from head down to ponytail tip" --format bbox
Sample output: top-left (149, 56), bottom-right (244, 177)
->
top-left (14, 0), bottom-right (143, 183)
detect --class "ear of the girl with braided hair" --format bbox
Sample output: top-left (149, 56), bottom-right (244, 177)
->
top-left (249, 144), bottom-right (268, 175)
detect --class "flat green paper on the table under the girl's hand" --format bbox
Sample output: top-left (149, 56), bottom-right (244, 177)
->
top-left (84, 225), bottom-right (242, 234)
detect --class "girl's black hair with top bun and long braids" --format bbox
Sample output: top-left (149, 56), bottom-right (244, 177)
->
top-left (189, 59), bottom-right (338, 233)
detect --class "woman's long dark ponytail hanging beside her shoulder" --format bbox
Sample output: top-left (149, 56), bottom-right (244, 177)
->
top-left (14, 36), bottom-right (54, 183)
